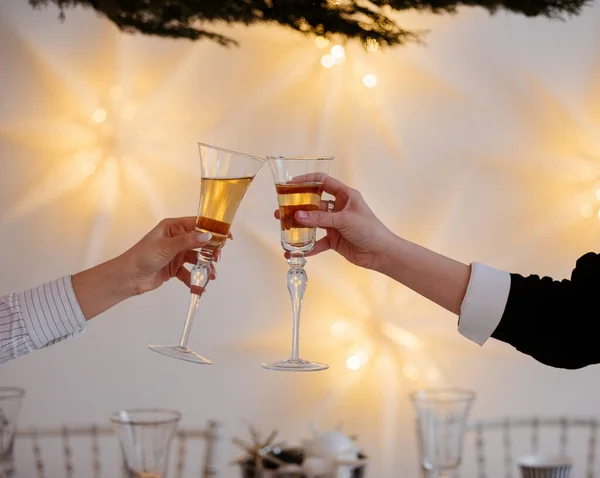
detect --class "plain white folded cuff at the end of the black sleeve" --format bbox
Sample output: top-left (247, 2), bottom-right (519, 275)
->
top-left (458, 262), bottom-right (510, 345)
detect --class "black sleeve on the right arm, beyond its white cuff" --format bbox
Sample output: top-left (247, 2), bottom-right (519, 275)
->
top-left (492, 252), bottom-right (600, 369)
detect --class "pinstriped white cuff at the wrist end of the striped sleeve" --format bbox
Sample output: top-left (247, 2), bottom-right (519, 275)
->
top-left (18, 276), bottom-right (87, 349)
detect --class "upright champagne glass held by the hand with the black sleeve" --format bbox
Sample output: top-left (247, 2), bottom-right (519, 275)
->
top-left (262, 156), bottom-right (333, 372)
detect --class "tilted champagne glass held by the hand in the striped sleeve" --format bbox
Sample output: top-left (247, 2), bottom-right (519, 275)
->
top-left (148, 143), bottom-right (266, 365)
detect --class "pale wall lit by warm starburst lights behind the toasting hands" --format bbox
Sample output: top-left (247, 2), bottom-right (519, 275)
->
top-left (0, 0), bottom-right (600, 477)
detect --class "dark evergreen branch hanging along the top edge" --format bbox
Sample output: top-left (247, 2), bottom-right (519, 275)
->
top-left (28, 0), bottom-right (591, 46)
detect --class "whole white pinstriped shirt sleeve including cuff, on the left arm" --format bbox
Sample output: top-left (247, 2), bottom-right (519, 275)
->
top-left (0, 276), bottom-right (86, 363)
